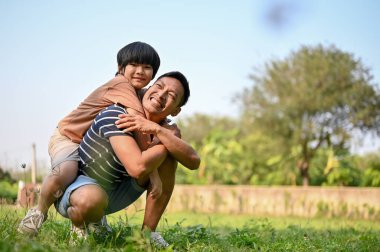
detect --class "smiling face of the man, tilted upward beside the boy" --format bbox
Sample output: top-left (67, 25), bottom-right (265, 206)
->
top-left (142, 77), bottom-right (185, 120)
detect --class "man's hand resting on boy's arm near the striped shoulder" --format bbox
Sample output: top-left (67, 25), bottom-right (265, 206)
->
top-left (115, 114), bottom-right (160, 135)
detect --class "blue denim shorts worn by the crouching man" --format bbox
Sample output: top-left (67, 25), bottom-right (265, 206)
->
top-left (55, 175), bottom-right (145, 218)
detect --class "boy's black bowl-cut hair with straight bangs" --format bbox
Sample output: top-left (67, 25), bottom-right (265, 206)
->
top-left (116, 41), bottom-right (160, 79)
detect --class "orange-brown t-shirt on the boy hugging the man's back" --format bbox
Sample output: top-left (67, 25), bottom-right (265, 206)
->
top-left (58, 75), bottom-right (145, 144)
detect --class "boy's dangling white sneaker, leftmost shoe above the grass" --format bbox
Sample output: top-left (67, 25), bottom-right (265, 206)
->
top-left (17, 208), bottom-right (47, 235)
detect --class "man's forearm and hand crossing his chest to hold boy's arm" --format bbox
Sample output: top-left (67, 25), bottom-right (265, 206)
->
top-left (116, 114), bottom-right (200, 170)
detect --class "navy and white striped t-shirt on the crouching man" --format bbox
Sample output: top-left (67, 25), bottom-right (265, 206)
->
top-left (79, 104), bottom-right (133, 190)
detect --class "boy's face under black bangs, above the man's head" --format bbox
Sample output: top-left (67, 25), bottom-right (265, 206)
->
top-left (123, 63), bottom-right (153, 90)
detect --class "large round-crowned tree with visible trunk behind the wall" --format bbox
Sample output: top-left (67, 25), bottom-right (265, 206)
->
top-left (237, 45), bottom-right (380, 185)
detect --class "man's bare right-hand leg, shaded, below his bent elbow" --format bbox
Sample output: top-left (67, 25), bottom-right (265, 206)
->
top-left (143, 156), bottom-right (177, 231)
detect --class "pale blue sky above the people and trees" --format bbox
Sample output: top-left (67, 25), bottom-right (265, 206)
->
top-left (0, 0), bottom-right (380, 171)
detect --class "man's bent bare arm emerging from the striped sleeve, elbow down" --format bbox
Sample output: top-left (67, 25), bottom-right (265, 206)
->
top-left (109, 136), bottom-right (167, 179)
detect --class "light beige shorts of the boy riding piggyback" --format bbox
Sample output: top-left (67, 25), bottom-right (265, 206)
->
top-left (48, 128), bottom-right (80, 170)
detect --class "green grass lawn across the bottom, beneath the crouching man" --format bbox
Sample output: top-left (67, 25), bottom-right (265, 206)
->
top-left (0, 206), bottom-right (380, 251)
